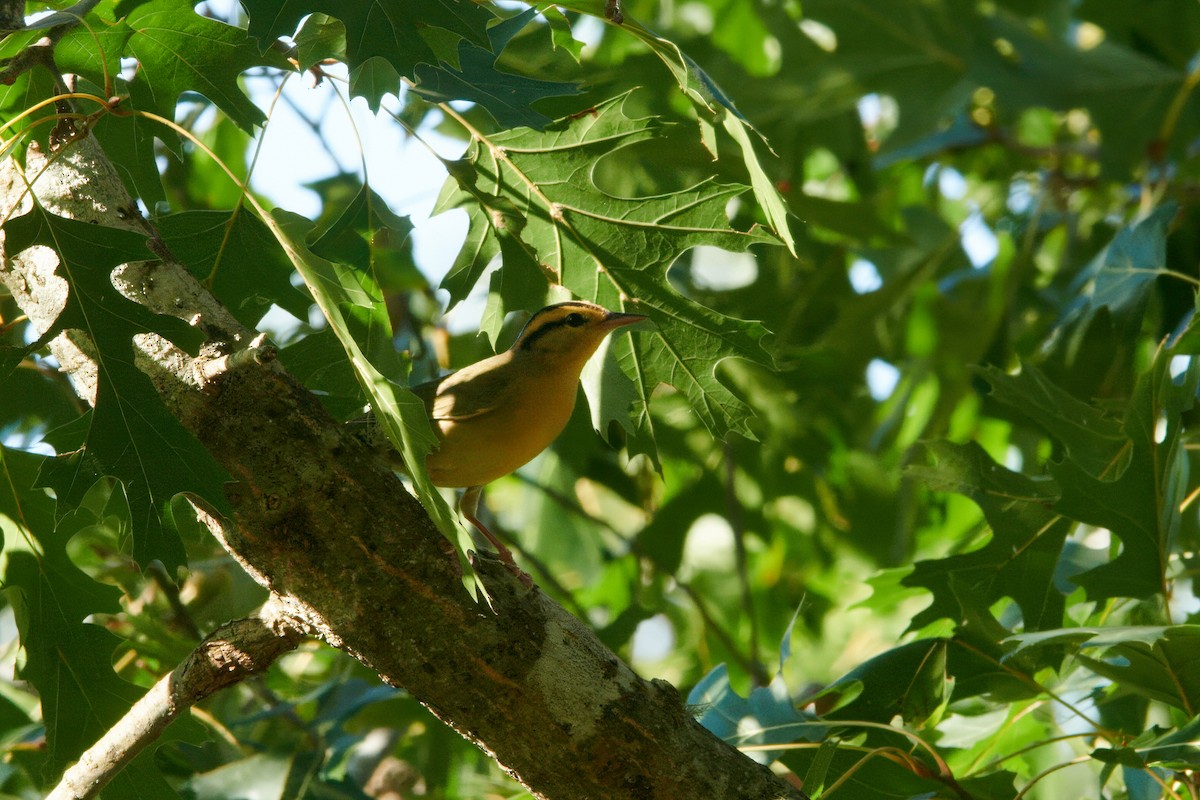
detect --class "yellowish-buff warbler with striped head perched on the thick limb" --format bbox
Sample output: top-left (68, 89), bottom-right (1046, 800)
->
top-left (364, 301), bottom-right (646, 563)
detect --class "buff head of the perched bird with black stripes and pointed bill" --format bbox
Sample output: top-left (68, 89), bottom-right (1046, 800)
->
top-left (511, 300), bottom-right (647, 366)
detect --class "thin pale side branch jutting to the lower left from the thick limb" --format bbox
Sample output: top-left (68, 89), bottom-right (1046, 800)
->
top-left (47, 603), bottom-right (301, 800)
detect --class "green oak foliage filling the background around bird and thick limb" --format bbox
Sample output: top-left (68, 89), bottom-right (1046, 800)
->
top-left (0, 0), bottom-right (1200, 800)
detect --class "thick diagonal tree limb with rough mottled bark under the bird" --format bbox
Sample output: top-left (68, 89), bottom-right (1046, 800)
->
top-left (0, 138), bottom-right (804, 800)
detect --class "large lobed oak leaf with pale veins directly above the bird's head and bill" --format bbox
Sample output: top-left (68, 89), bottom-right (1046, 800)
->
top-left (438, 95), bottom-right (778, 437)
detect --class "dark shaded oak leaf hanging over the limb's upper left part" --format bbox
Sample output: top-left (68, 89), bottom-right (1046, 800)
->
top-left (4, 207), bottom-right (226, 569)
